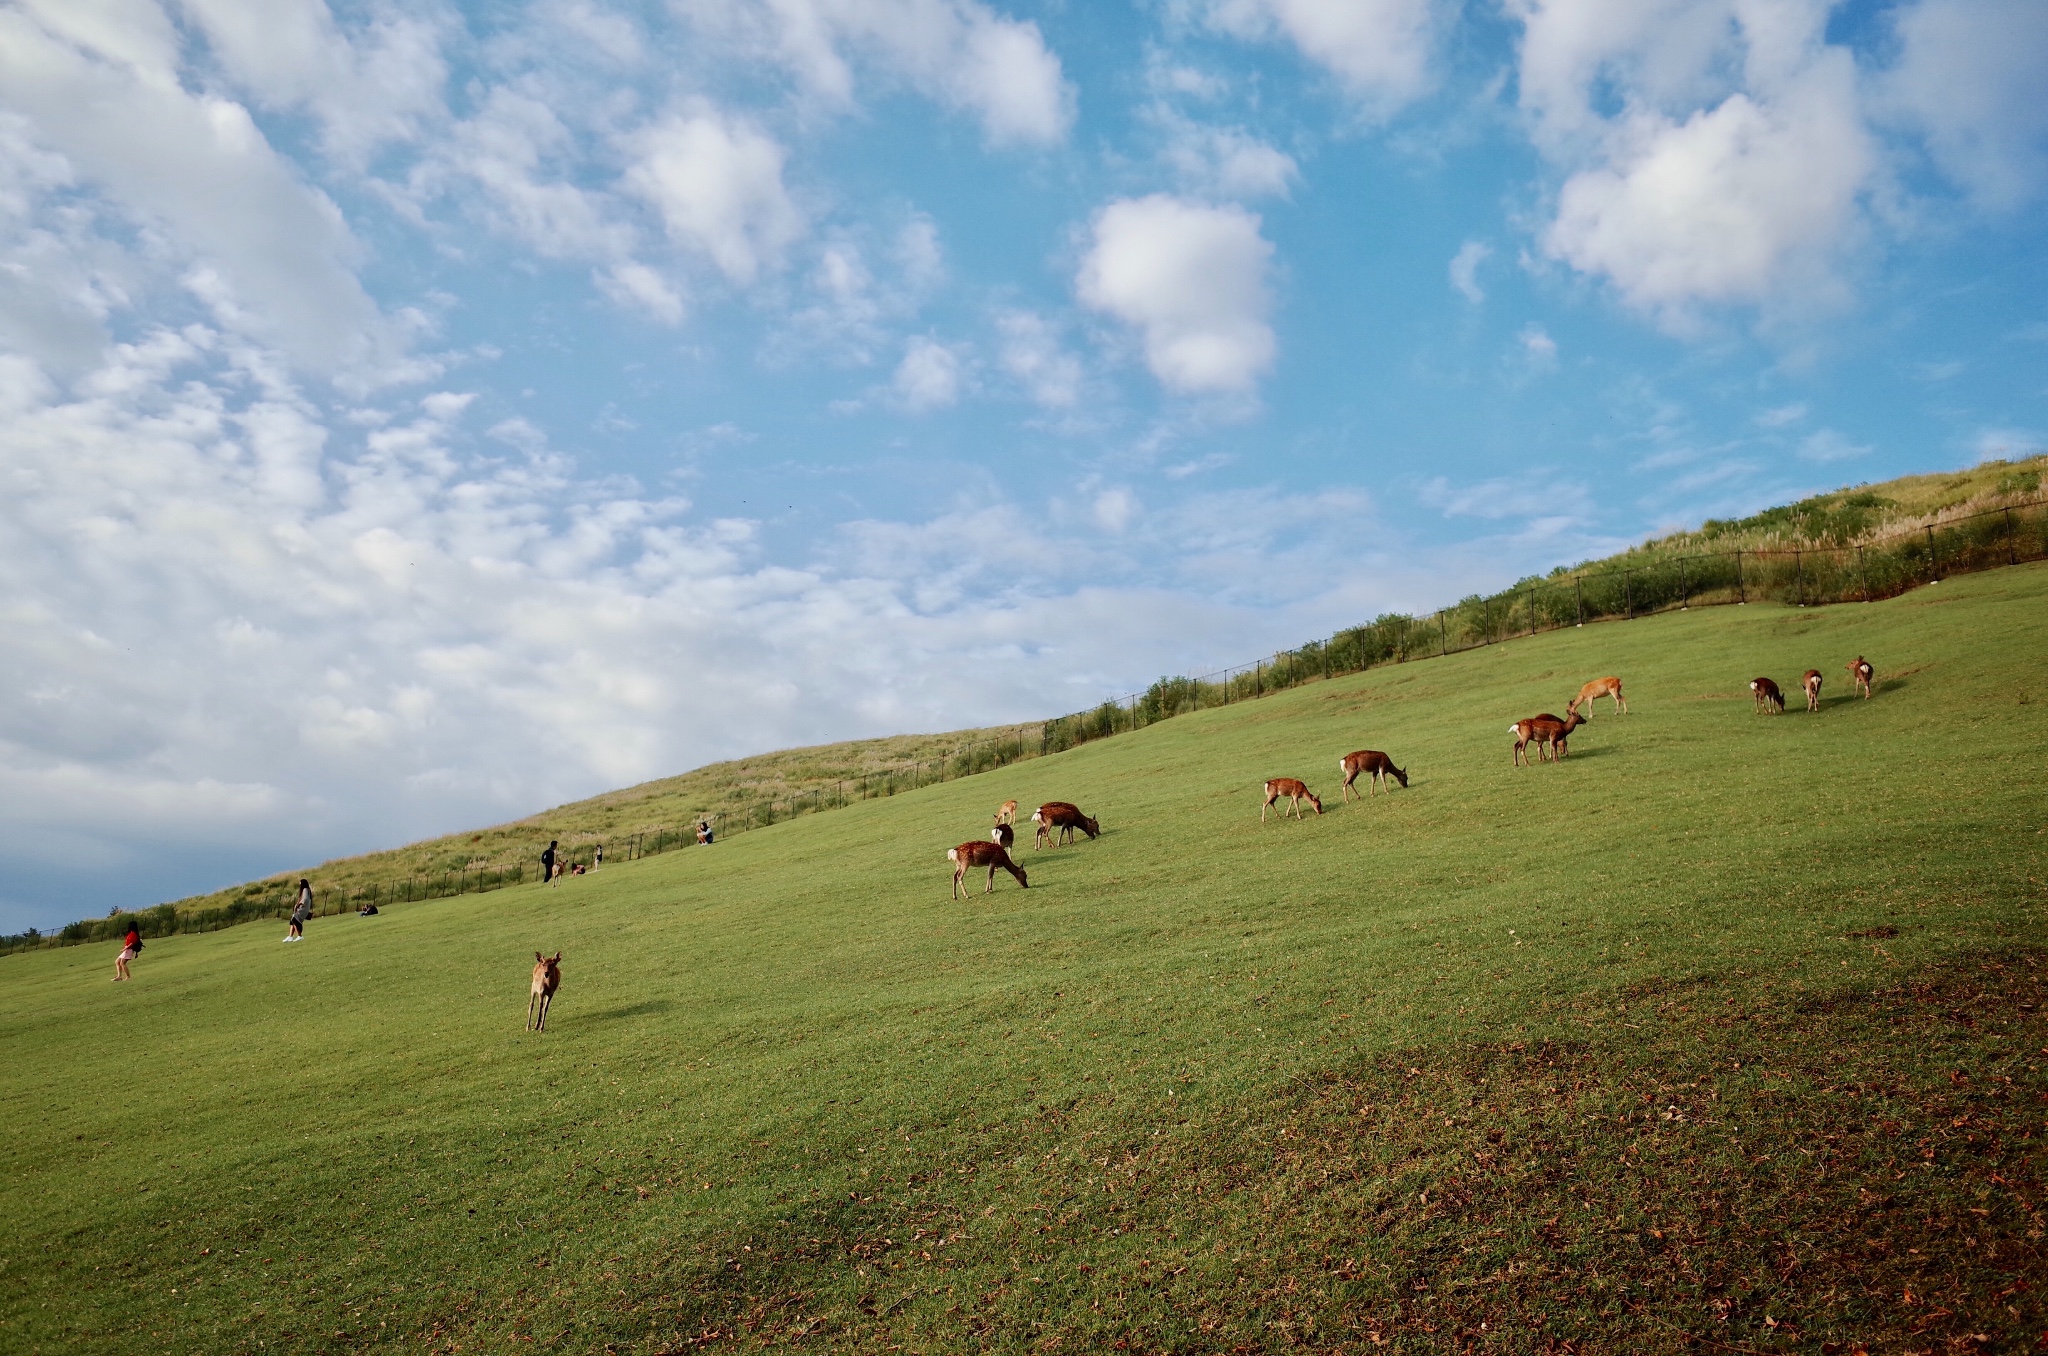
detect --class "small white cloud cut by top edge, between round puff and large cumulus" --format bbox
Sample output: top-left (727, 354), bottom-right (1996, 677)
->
top-left (1208, 0), bottom-right (1436, 113)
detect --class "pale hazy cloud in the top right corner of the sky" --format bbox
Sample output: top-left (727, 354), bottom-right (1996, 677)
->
top-left (1878, 0), bottom-right (2048, 209)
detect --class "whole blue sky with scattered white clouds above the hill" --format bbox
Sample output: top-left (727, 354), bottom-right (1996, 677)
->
top-left (0, 0), bottom-right (2048, 928)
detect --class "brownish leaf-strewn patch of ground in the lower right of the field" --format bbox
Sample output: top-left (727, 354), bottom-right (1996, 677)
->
top-left (614, 952), bottom-right (2048, 1354)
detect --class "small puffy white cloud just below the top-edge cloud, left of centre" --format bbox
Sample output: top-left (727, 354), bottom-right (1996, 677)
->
top-left (625, 111), bottom-right (803, 287)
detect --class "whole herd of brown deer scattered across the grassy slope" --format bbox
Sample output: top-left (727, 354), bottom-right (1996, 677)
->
top-left (526, 655), bottom-right (1874, 1030)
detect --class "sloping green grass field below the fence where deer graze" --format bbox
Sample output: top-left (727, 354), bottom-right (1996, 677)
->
top-left (0, 567), bottom-right (2048, 1354)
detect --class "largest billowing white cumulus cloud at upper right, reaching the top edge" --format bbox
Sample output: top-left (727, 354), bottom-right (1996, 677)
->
top-left (1509, 0), bottom-right (1880, 328)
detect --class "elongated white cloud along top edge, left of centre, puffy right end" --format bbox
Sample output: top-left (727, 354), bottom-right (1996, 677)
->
top-left (678, 0), bottom-right (1073, 145)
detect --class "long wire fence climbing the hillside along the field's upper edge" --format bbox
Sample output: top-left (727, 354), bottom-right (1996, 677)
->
top-left (0, 500), bottom-right (2048, 955)
